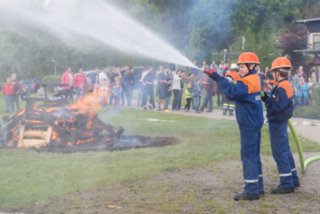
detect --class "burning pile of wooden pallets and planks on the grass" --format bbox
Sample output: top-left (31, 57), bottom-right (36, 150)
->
top-left (0, 98), bottom-right (124, 148)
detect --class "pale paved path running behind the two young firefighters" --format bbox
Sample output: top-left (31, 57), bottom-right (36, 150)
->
top-left (170, 109), bottom-right (320, 144)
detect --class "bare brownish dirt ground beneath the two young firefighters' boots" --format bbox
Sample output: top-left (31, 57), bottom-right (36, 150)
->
top-left (25, 154), bottom-right (320, 214)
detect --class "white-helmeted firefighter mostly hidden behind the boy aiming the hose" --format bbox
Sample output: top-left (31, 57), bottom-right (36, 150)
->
top-left (222, 63), bottom-right (240, 116)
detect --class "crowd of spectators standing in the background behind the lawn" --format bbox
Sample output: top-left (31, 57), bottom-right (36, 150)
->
top-left (2, 61), bottom-right (320, 115)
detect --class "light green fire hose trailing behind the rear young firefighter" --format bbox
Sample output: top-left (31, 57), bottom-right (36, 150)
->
top-left (288, 120), bottom-right (320, 173)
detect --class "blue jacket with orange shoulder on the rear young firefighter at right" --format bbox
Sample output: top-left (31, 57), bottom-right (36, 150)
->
top-left (265, 79), bottom-right (294, 123)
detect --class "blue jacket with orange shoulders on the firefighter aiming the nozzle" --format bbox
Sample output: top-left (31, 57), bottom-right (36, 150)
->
top-left (216, 70), bottom-right (263, 128)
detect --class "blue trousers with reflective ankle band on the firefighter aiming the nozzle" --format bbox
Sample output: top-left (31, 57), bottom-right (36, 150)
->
top-left (239, 125), bottom-right (264, 195)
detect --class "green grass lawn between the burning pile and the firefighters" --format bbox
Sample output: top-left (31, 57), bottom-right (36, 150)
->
top-left (0, 105), bottom-right (320, 211)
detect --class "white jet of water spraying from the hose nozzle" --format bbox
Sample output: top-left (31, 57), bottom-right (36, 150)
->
top-left (0, 0), bottom-right (196, 67)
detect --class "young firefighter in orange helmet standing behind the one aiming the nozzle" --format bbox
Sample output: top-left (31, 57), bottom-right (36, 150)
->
top-left (261, 57), bottom-right (300, 194)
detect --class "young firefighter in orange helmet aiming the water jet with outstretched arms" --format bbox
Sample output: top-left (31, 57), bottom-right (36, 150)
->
top-left (205, 52), bottom-right (264, 201)
